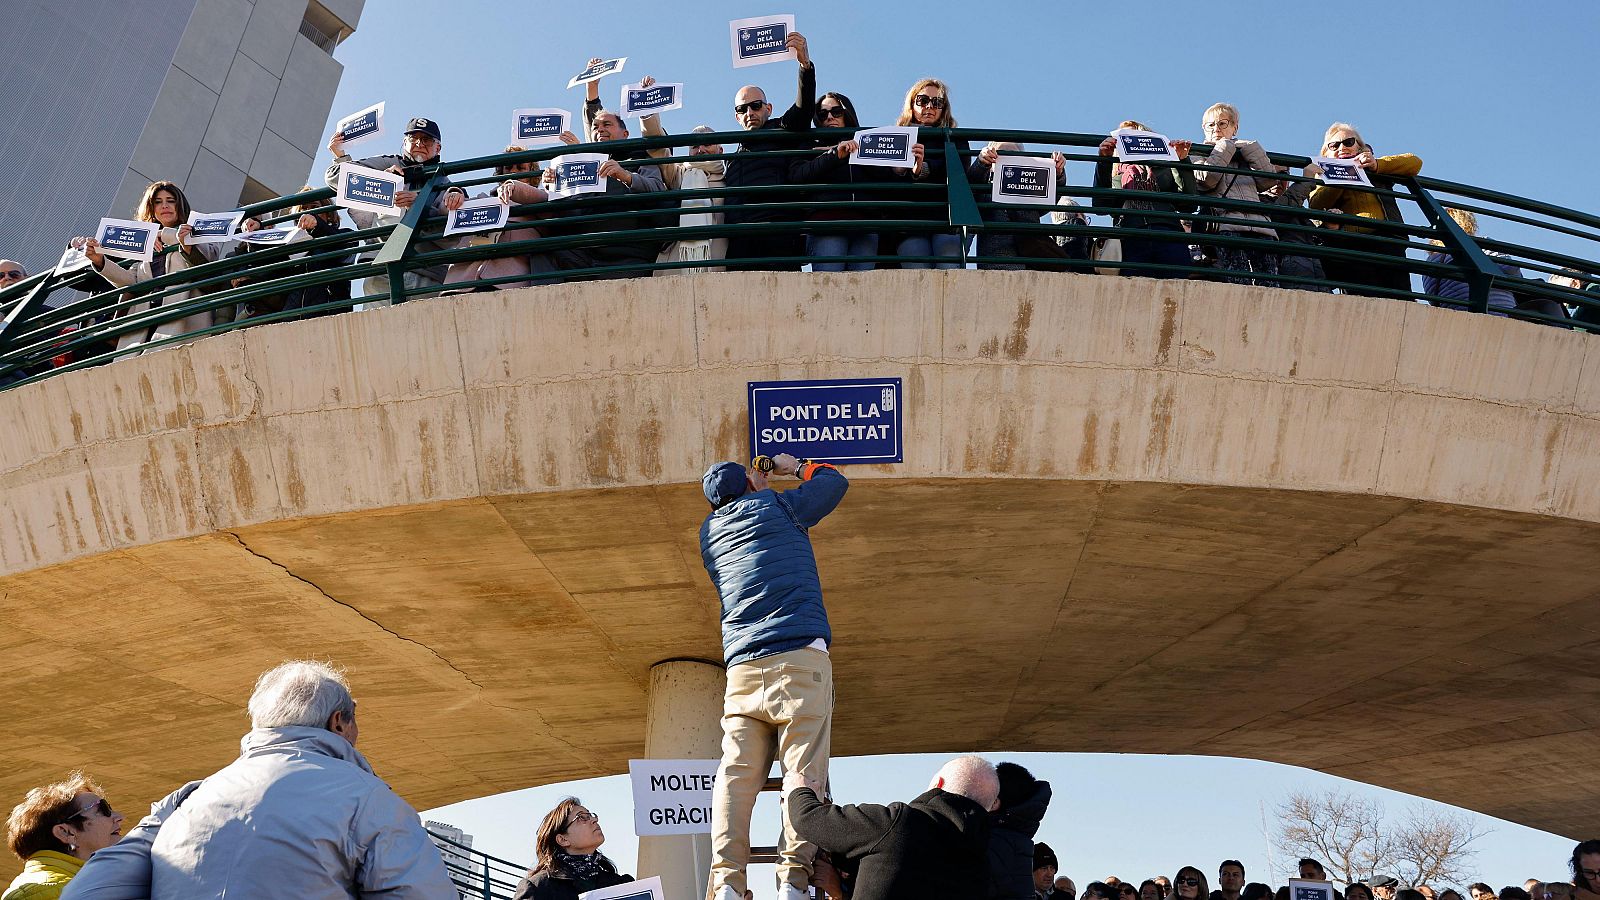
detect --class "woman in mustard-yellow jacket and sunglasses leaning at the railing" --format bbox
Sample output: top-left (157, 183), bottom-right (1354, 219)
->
top-left (1306, 122), bottom-right (1422, 296)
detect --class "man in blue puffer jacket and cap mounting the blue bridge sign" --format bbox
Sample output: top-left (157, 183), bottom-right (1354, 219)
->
top-left (701, 453), bottom-right (850, 900)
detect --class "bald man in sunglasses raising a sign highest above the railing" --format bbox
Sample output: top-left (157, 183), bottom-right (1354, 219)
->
top-left (723, 32), bottom-right (816, 271)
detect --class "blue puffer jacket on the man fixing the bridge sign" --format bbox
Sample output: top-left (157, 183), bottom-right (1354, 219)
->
top-left (701, 464), bottom-right (850, 666)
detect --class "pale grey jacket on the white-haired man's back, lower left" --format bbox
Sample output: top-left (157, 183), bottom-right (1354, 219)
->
top-left (146, 725), bottom-right (458, 900)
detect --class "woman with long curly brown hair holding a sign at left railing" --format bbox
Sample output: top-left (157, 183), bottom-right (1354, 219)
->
top-left (72, 181), bottom-right (230, 351)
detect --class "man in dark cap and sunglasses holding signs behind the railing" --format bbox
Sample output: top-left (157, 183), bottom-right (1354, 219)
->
top-left (326, 119), bottom-right (467, 307)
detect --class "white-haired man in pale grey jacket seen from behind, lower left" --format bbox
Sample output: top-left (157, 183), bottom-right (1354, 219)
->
top-left (62, 661), bottom-right (459, 900)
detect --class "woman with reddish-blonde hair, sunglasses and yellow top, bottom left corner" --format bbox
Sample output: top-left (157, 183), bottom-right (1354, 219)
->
top-left (0, 772), bottom-right (122, 900)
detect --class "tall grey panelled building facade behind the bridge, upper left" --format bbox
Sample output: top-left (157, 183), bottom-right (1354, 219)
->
top-left (0, 0), bottom-right (365, 272)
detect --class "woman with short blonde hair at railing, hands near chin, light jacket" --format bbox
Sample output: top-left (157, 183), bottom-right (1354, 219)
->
top-left (1189, 102), bottom-right (1280, 287)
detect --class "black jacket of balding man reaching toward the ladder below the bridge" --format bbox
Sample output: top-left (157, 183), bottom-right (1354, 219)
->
top-left (787, 788), bottom-right (989, 900)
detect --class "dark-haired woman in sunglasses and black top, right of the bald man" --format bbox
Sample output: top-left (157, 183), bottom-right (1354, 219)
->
top-left (789, 91), bottom-right (883, 272)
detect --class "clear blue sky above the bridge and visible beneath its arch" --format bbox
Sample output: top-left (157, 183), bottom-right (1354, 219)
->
top-left (315, 0), bottom-right (1600, 897)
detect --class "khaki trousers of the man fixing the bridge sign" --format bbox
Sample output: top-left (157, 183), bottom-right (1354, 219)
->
top-left (707, 647), bottom-right (834, 900)
